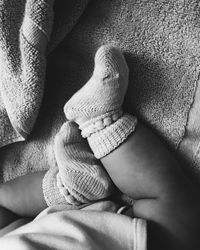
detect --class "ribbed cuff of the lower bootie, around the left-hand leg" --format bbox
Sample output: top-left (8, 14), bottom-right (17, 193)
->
top-left (42, 167), bottom-right (66, 207)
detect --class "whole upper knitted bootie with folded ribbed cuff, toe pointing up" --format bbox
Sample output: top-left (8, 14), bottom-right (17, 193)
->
top-left (64, 45), bottom-right (137, 159)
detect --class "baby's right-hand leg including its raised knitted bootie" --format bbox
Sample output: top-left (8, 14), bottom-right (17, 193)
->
top-left (65, 46), bottom-right (200, 249)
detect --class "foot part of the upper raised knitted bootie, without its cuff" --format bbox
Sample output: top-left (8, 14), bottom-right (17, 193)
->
top-left (64, 45), bottom-right (129, 126)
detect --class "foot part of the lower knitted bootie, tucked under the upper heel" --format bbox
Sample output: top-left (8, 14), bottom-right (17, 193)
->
top-left (54, 122), bottom-right (113, 205)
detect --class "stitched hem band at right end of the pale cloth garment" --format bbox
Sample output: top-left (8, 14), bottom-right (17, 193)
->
top-left (133, 218), bottom-right (147, 250)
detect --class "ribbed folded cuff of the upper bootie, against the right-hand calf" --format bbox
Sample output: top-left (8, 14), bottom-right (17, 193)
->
top-left (87, 114), bottom-right (137, 159)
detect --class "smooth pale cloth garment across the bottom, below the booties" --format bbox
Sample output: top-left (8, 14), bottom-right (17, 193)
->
top-left (0, 204), bottom-right (147, 250)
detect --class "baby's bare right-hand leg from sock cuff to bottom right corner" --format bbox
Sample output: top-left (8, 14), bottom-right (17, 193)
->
top-left (101, 124), bottom-right (200, 250)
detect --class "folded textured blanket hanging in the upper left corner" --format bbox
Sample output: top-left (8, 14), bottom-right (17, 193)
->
top-left (0, 0), bottom-right (88, 147)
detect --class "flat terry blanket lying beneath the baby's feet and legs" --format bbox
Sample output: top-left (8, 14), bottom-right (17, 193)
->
top-left (0, 0), bottom-right (200, 188)
